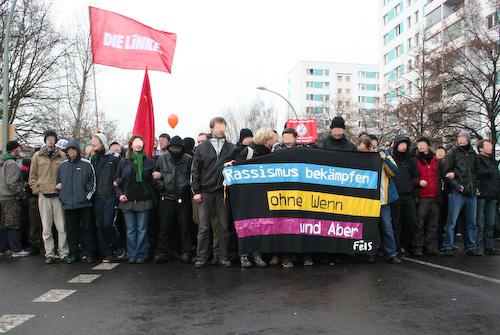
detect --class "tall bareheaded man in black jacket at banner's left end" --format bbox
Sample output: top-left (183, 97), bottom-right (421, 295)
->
top-left (191, 117), bottom-right (236, 268)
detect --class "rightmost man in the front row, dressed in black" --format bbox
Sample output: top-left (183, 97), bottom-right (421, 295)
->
top-left (477, 140), bottom-right (500, 256)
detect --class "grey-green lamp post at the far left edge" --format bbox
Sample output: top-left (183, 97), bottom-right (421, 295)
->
top-left (2, 0), bottom-right (17, 152)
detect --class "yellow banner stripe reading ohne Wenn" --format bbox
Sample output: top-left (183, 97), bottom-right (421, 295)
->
top-left (267, 190), bottom-right (380, 217)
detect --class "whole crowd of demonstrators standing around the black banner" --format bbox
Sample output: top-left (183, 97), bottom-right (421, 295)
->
top-left (0, 117), bottom-right (500, 268)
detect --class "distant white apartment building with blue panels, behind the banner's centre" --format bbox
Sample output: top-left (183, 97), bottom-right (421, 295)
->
top-left (288, 61), bottom-right (380, 132)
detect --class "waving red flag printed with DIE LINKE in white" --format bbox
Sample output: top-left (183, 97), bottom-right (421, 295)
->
top-left (89, 7), bottom-right (177, 73)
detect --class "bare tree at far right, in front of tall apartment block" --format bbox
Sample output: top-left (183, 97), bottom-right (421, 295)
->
top-left (443, 0), bottom-right (500, 151)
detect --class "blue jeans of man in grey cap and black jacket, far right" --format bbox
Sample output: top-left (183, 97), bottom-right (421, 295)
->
top-left (443, 192), bottom-right (478, 250)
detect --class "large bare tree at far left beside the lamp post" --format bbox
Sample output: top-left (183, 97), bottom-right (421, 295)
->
top-left (0, 0), bottom-right (66, 142)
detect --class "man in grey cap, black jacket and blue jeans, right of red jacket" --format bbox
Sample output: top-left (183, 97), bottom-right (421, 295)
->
top-left (443, 131), bottom-right (482, 256)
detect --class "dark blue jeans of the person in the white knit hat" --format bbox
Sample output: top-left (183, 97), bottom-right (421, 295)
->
top-left (94, 196), bottom-right (122, 257)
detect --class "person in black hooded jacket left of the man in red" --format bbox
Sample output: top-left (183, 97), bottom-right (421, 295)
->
top-left (391, 135), bottom-right (420, 254)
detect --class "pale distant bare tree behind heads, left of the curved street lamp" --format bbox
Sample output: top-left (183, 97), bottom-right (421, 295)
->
top-left (223, 99), bottom-right (278, 141)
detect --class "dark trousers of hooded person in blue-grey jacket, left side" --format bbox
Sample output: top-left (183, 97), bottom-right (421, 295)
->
top-left (64, 207), bottom-right (96, 258)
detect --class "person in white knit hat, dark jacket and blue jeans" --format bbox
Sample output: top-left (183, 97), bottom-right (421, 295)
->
top-left (90, 133), bottom-right (125, 263)
